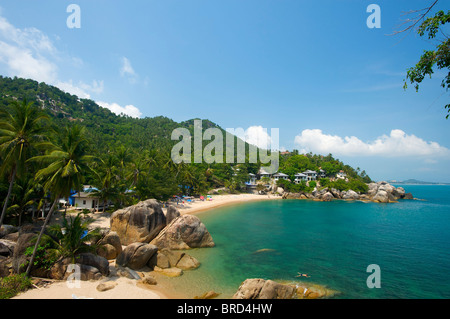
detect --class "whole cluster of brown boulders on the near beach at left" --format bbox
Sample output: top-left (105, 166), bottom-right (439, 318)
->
top-left (0, 199), bottom-right (214, 290)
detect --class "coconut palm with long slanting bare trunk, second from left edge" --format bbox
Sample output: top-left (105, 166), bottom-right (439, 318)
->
top-left (26, 125), bottom-right (94, 276)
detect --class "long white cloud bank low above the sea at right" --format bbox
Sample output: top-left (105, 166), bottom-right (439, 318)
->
top-left (295, 129), bottom-right (450, 157)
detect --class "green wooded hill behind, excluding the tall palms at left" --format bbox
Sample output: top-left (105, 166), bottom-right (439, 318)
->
top-left (0, 76), bottom-right (370, 226)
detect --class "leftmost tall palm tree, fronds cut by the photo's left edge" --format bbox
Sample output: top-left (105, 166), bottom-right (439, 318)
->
top-left (0, 100), bottom-right (48, 227)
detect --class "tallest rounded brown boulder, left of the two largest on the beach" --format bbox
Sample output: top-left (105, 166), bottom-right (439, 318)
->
top-left (111, 199), bottom-right (166, 246)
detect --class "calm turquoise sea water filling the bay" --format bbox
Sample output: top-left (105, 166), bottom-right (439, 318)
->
top-left (168, 185), bottom-right (450, 298)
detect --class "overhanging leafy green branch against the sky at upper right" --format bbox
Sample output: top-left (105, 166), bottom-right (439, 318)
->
top-left (403, 11), bottom-right (450, 119)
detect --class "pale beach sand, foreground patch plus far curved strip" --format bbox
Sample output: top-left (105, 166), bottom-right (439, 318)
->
top-left (13, 194), bottom-right (281, 299)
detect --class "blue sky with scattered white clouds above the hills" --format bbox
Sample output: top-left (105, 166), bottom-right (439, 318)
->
top-left (0, 0), bottom-right (450, 182)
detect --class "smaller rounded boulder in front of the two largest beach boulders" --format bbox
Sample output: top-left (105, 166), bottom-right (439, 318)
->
top-left (116, 243), bottom-right (158, 270)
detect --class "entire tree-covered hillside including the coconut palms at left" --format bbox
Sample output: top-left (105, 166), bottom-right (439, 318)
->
top-left (0, 76), bottom-right (370, 228)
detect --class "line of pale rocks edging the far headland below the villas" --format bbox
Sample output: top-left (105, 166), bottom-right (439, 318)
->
top-left (282, 182), bottom-right (413, 203)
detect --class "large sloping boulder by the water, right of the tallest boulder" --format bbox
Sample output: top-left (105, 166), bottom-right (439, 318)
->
top-left (150, 215), bottom-right (215, 249)
